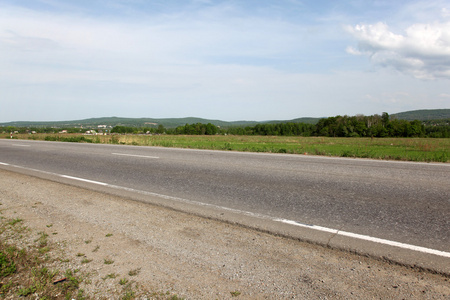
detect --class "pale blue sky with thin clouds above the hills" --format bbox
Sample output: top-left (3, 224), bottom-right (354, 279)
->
top-left (0, 0), bottom-right (450, 122)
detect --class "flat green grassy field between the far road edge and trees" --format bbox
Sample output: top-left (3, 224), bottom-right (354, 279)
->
top-left (0, 134), bottom-right (450, 162)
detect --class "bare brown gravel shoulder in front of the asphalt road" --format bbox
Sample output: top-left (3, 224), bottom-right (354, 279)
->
top-left (0, 170), bottom-right (450, 299)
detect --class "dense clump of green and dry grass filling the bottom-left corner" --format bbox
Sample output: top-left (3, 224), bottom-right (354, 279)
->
top-left (0, 218), bottom-right (84, 299)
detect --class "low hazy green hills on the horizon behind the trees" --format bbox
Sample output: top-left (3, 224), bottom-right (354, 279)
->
top-left (0, 109), bottom-right (450, 128)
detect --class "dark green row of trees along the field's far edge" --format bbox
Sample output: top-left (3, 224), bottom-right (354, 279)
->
top-left (3, 113), bottom-right (450, 138)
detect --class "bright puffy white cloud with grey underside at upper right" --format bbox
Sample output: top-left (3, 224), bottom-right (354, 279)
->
top-left (347, 22), bottom-right (450, 79)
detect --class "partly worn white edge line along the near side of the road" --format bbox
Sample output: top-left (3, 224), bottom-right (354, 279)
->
top-left (0, 162), bottom-right (450, 258)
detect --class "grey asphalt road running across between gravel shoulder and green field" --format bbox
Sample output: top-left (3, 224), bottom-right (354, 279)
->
top-left (0, 140), bottom-right (450, 268)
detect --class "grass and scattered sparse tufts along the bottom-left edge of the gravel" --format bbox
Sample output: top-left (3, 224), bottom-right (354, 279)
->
top-left (0, 213), bottom-right (181, 300)
